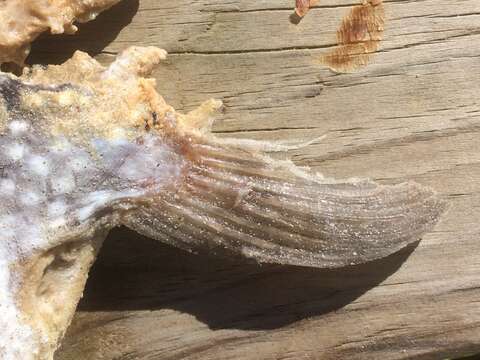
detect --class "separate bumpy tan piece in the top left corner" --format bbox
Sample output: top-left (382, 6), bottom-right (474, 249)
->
top-left (0, 0), bottom-right (120, 65)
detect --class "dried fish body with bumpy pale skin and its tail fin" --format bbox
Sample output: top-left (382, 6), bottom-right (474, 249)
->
top-left (0, 48), bottom-right (444, 360)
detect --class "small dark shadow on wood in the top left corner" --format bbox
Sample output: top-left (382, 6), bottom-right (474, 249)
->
top-left (27, 0), bottom-right (140, 65)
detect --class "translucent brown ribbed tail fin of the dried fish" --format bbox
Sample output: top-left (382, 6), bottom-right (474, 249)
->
top-left (124, 137), bottom-right (445, 268)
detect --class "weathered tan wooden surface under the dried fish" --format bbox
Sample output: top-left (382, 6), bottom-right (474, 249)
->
top-left (31, 0), bottom-right (480, 360)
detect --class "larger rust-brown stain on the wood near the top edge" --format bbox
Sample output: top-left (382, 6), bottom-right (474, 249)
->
top-left (321, 0), bottom-right (385, 72)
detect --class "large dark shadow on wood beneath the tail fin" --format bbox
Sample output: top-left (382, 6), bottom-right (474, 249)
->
top-left (79, 229), bottom-right (416, 330)
